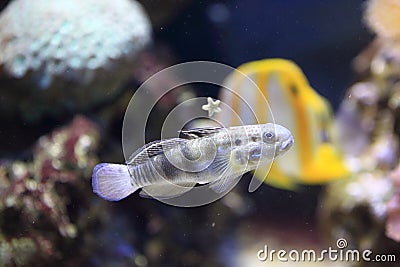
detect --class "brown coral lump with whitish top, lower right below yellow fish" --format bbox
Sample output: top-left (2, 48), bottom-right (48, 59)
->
top-left (321, 171), bottom-right (392, 245)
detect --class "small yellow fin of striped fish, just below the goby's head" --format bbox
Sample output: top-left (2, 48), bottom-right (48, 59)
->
top-left (254, 163), bottom-right (297, 191)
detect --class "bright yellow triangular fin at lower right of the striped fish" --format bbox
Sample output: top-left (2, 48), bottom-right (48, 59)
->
top-left (299, 143), bottom-right (350, 184)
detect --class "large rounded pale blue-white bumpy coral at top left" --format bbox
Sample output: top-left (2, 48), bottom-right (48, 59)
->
top-left (0, 0), bottom-right (151, 120)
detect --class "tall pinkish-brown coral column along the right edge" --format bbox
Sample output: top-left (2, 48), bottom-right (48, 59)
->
top-left (320, 6), bottom-right (400, 266)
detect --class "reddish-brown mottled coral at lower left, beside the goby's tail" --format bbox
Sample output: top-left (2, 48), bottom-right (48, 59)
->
top-left (0, 116), bottom-right (106, 266)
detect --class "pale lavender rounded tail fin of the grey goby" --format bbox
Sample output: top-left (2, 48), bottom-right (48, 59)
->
top-left (92, 163), bottom-right (138, 201)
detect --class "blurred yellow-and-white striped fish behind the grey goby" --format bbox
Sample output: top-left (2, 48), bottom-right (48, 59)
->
top-left (216, 59), bottom-right (349, 189)
